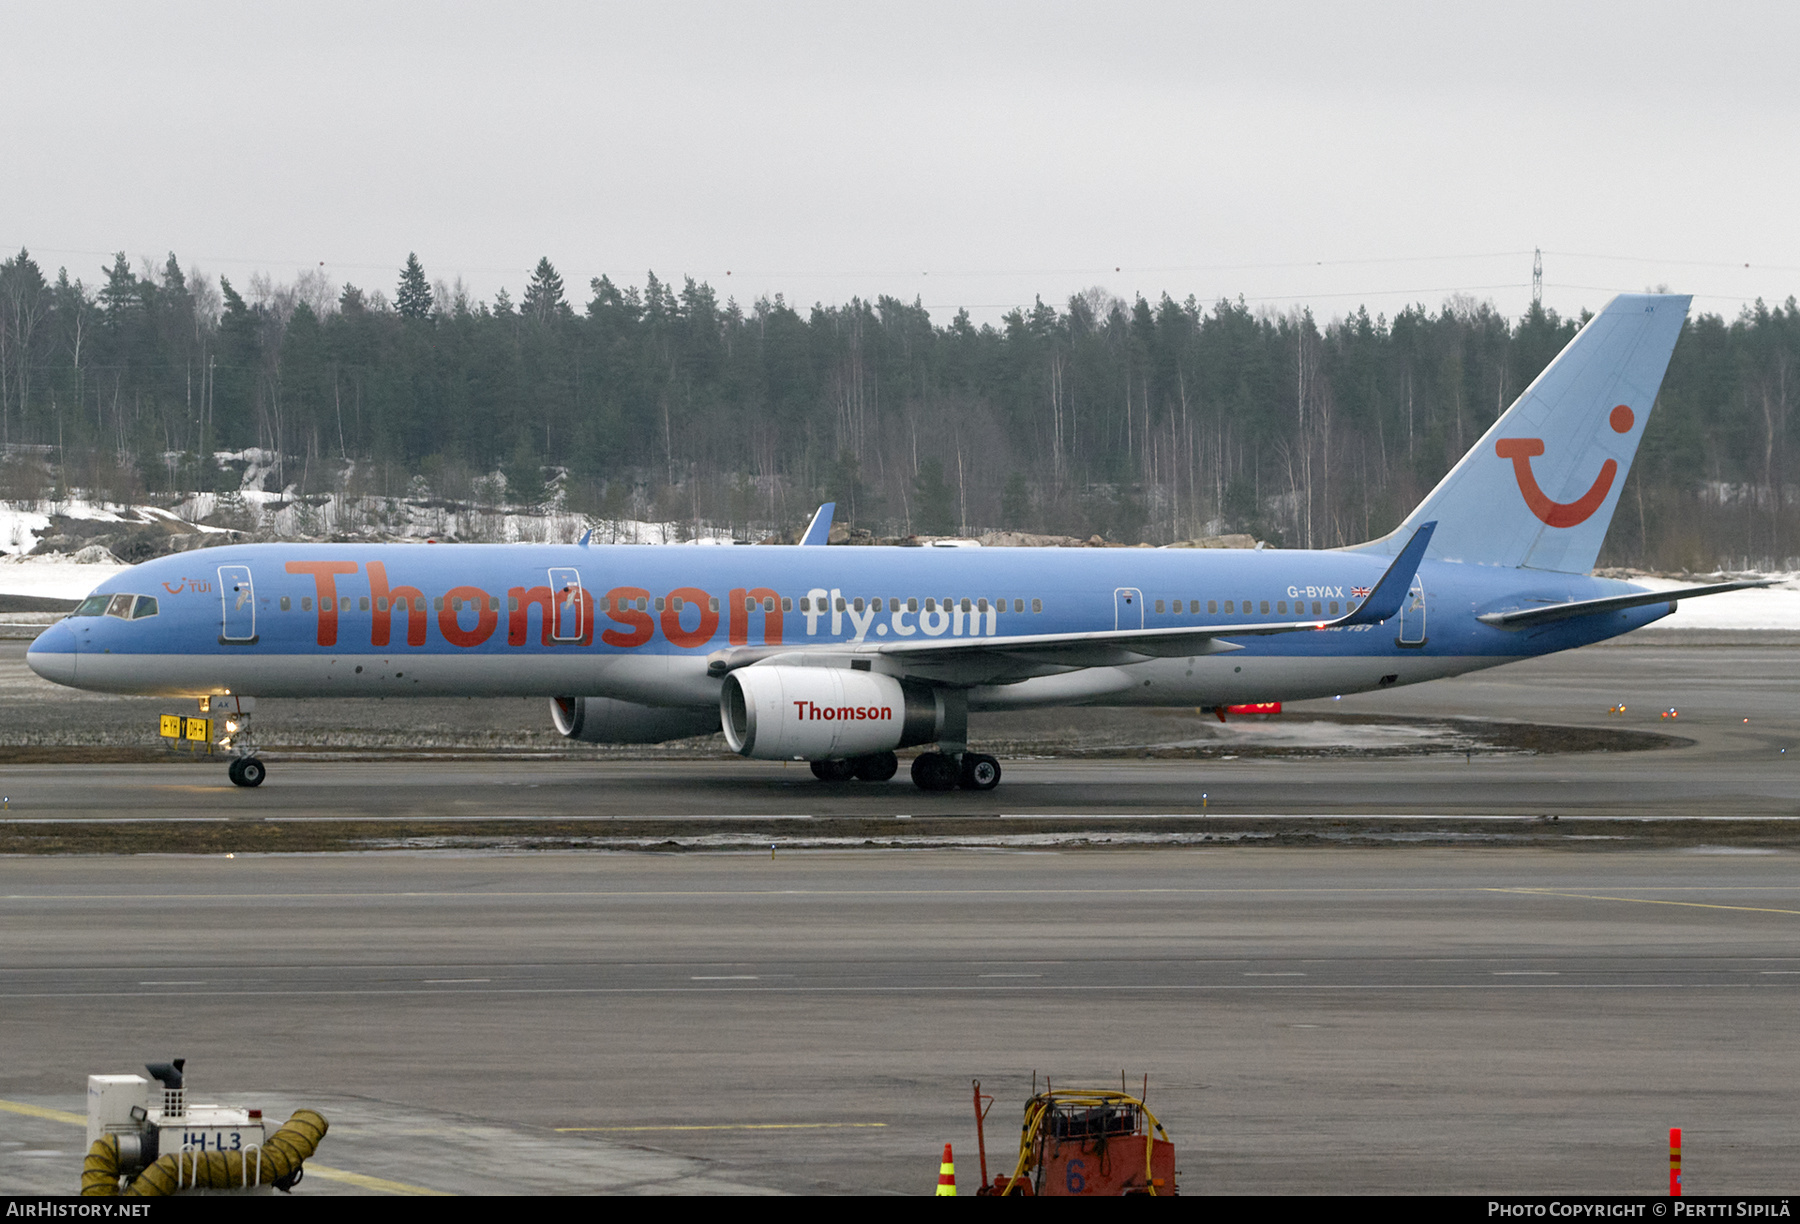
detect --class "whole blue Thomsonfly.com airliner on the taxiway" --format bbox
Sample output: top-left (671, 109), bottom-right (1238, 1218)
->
top-left (27, 293), bottom-right (1757, 790)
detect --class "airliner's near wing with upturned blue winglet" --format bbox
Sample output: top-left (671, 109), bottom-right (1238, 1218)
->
top-left (707, 522), bottom-right (1436, 682)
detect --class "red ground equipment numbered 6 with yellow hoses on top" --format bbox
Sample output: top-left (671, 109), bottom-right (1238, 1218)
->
top-left (974, 1076), bottom-right (1179, 1195)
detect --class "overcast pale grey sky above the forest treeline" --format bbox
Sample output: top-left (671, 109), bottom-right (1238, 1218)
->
top-left (0, 0), bottom-right (1800, 322)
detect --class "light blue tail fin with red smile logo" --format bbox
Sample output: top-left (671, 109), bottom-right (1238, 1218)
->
top-left (1357, 293), bottom-right (1692, 574)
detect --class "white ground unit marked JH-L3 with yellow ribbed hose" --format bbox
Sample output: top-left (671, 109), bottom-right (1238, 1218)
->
top-left (81, 1058), bottom-right (328, 1199)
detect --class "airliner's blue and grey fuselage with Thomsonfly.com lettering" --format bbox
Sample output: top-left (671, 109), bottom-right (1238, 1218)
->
top-left (27, 544), bottom-right (1672, 709)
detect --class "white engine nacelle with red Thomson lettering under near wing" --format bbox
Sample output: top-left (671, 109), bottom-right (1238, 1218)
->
top-left (718, 666), bottom-right (943, 761)
